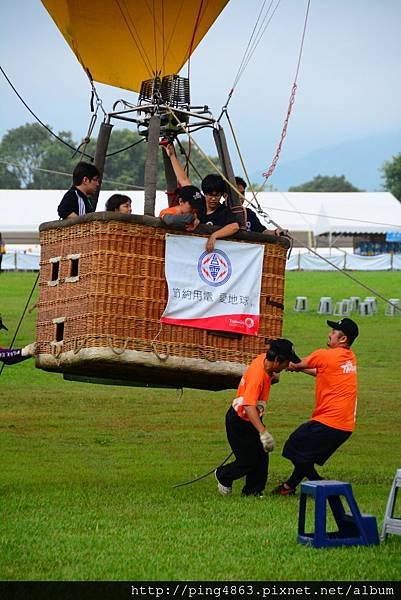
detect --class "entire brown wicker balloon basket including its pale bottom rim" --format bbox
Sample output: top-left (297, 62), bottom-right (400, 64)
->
top-left (36, 213), bottom-right (288, 389)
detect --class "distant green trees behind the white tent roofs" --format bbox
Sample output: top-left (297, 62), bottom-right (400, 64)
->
top-left (0, 123), bottom-right (401, 201)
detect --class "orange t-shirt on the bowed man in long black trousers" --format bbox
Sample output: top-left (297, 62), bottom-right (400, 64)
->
top-left (232, 354), bottom-right (272, 421)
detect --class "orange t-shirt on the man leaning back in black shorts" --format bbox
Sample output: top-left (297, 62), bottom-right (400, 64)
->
top-left (304, 348), bottom-right (357, 431)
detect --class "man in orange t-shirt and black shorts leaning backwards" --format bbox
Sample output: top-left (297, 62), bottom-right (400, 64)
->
top-left (272, 318), bottom-right (359, 496)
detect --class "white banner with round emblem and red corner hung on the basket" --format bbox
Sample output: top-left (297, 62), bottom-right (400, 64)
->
top-left (160, 234), bottom-right (264, 335)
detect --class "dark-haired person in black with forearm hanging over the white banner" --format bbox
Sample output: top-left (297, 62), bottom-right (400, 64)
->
top-left (163, 144), bottom-right (239, 252)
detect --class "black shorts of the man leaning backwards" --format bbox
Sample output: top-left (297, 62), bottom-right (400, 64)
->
top-left (283, 421), bottom-right (352, 465)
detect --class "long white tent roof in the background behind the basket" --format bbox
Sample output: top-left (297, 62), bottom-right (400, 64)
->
top-left (0, 190), bottom-right (401, 243)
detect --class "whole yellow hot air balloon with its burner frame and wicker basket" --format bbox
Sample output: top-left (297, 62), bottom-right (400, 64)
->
top-left (36, 0), bottom-right (289, 389)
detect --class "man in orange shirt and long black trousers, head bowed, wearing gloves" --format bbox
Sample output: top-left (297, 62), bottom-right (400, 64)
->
top-left (215, 339), bottom-right (300, 496)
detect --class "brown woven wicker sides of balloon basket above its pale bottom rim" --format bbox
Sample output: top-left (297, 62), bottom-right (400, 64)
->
top-left (36, 219), bottom-right (286, 375)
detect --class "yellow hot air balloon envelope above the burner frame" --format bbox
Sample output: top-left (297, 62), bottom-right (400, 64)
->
top-left (42, 0), bottom-right (229, 91)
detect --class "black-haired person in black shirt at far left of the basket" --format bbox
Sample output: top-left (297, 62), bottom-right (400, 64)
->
top-left (57, 162), bottom-right (100, 219)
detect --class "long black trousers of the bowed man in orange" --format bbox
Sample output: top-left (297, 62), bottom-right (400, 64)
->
top-left (217, 407), bottom-right (269, 495)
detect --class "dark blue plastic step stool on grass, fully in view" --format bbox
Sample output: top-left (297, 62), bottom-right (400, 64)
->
top-left (298, 480), bottom-right (380, 548)
